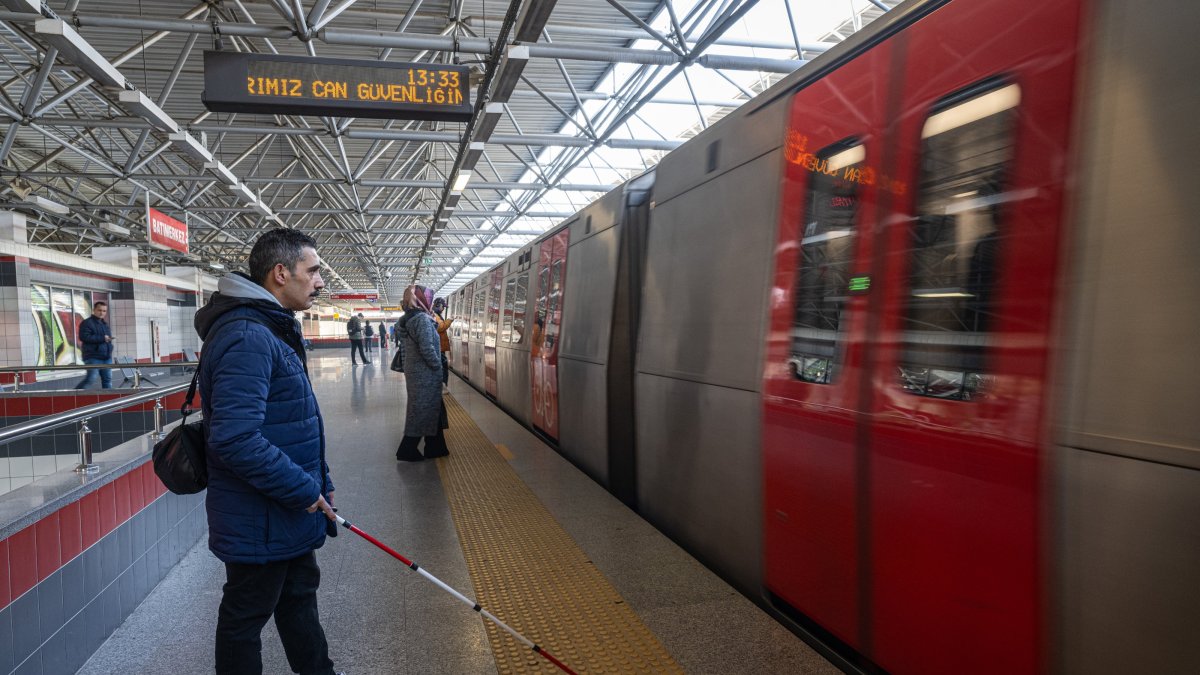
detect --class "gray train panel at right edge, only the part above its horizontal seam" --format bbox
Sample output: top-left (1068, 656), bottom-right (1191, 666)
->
top-left (1068, 0), bottom-right (1200, 468)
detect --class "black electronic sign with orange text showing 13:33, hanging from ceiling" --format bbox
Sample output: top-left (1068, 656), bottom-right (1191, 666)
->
top-left (202, 52), bottom-right (472, 121)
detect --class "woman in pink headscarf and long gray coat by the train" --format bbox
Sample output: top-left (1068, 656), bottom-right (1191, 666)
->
top-left (396, 281), bottom-right (450, 461)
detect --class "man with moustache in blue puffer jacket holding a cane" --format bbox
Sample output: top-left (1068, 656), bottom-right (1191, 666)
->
top-left (196, 229), bottom-right (337, 675)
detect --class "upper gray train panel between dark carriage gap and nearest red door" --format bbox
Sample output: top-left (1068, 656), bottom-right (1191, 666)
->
top-left (637, 147), bottom-right (782, 390)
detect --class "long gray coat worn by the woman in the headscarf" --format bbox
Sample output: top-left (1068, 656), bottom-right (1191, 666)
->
top-left (400, 311), bottom-right (442, 436)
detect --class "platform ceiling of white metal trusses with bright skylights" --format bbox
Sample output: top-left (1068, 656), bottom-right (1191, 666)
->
top-left (0, 0), bottom-right (896, 303)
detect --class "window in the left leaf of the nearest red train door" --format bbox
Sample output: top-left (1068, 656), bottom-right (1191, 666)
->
top-left (788, 139), bottom-right (866, 384)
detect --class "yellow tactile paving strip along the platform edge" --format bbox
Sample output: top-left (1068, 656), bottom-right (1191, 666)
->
top-left (438, 395), bottom-right (683, 675)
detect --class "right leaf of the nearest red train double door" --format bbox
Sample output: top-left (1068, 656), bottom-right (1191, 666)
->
top-left (863, 0), bottom-right (1080, 674)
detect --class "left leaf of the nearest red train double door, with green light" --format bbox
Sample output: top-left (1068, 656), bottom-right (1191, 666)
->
top-left (762, 43), bottom-right (892, 650)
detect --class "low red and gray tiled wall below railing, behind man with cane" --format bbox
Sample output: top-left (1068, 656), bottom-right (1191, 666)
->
top-left (0, 462), bottom-right (205, 675)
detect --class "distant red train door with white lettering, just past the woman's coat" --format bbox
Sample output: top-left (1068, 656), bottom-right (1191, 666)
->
top-left (530, 226), bottom-right (570, 438)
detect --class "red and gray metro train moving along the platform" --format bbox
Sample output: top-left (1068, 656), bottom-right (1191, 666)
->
top-left (450, 0), bottom-right (1200, 674)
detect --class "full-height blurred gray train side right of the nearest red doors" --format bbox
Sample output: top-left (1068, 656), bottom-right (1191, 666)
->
top-left (1052, 0), bottom-right (1200, 674)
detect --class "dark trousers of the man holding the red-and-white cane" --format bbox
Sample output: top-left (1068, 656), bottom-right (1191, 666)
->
top-left (216, 551), bottom-right (334, 675)
